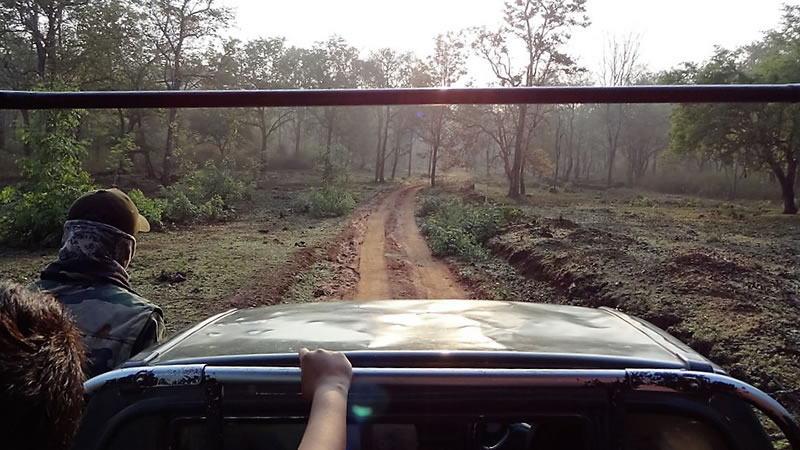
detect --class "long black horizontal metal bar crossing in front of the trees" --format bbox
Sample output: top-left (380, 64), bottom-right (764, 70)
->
top-left (0, 84), bottom-right (800, 109)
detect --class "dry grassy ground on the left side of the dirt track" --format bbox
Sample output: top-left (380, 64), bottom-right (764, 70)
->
top-left (0, 172), bottom-right (386, 333)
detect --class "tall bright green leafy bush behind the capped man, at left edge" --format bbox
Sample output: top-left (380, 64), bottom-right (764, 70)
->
top-left (0, 111), bottom-right (94, 246)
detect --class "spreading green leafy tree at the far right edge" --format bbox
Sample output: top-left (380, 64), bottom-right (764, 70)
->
top-left (667, 6), bottom-right (800, 214)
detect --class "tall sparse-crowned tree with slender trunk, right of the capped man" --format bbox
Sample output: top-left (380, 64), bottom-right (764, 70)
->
top-left (143, 0), bottom-right (232, 185)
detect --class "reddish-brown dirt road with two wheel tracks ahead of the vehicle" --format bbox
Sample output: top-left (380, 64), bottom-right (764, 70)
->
top-left (354, 186), bottom-right (465, 300)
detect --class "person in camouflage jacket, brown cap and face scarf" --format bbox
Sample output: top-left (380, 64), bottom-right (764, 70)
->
top-left (32, 189), bottom-right (165, 377)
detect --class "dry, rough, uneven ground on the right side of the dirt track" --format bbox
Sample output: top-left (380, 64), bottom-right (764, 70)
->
top-left (424, 178), bottom-right (800, 414)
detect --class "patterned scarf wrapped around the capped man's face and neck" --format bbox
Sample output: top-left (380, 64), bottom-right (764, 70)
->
top-left (42, 220), bottom-right (136, 290)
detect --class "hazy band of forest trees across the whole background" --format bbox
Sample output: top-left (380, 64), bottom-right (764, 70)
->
top-left (0, 0), bottom-right (800, 243)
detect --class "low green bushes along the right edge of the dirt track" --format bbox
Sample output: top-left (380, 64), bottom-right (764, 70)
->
top-left (418, 196), bottom-right (522, 261)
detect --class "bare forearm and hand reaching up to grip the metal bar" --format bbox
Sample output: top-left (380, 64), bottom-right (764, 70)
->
top-left (300, 349), bottom-right (353, 450)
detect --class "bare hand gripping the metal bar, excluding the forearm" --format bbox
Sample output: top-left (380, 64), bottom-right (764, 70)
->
top-left (299, 348), bottom-right (353, 400)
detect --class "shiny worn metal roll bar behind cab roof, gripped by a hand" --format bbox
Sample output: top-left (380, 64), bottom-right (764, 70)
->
top-left (84, 364), bottom-right (800, 448)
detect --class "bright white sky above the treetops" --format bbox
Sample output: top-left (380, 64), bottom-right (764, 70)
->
top-left (219, 0), bottom-right (797, 84)
